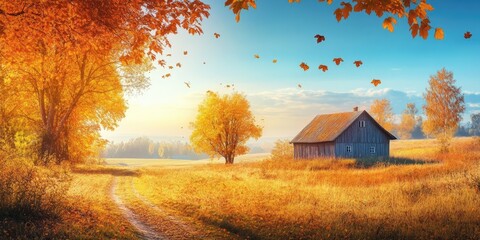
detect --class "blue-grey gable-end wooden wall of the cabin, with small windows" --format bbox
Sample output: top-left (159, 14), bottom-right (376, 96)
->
top-left (335, 114), bottom-right (390, 158)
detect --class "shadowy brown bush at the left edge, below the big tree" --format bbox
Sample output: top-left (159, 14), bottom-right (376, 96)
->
top-left (0, 152), bottom-right (70, 219)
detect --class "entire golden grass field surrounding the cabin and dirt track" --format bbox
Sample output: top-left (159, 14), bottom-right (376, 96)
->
top-left (0, 138), bottom-right (480, 239)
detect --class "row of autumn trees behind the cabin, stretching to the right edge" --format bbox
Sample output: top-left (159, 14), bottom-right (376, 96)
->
top-left (369, 68), bottom-right (480, 145)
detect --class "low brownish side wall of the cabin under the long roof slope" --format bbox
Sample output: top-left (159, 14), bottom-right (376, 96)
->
top-left (293, 142), bottom-right (335, 159)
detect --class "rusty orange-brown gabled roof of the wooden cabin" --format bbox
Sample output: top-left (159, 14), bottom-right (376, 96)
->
top-left (291, 111), bottom-right (397, 143)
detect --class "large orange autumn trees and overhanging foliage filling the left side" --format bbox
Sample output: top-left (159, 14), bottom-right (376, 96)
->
top-left (0, 0), bottom-right (210, 164)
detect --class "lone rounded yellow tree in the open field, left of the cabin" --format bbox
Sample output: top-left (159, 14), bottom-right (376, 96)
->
top-left (190, 92), bottom-right (262, 164)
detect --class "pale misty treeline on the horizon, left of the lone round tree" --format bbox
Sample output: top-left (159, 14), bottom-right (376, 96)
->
top-left (102, 137), bottom-right (208, 159)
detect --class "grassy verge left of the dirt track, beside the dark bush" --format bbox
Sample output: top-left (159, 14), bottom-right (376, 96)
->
top-left (0, 167), bottom-right (138, 239)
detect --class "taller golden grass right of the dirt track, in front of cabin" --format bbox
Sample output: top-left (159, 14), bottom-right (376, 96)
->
top-left (134, 139), bottom-right (480, 239)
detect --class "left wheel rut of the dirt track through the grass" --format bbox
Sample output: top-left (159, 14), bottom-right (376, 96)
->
top-left (110, 177), bottom-right (167, 240)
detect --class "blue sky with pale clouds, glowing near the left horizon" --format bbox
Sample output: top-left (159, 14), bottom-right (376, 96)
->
top-left (99, 0), bottom-right (480, 141)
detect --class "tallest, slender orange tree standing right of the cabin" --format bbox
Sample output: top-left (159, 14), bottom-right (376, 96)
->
top-left (423, 68), bottom-right (465, 152)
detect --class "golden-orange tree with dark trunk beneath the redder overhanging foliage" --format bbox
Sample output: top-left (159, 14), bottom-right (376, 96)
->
top-left (10, 45), bottom-right (129, 163)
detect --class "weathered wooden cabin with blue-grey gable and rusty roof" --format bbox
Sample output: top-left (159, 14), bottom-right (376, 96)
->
top-left (291, 108), bottom-right (397, 159)
